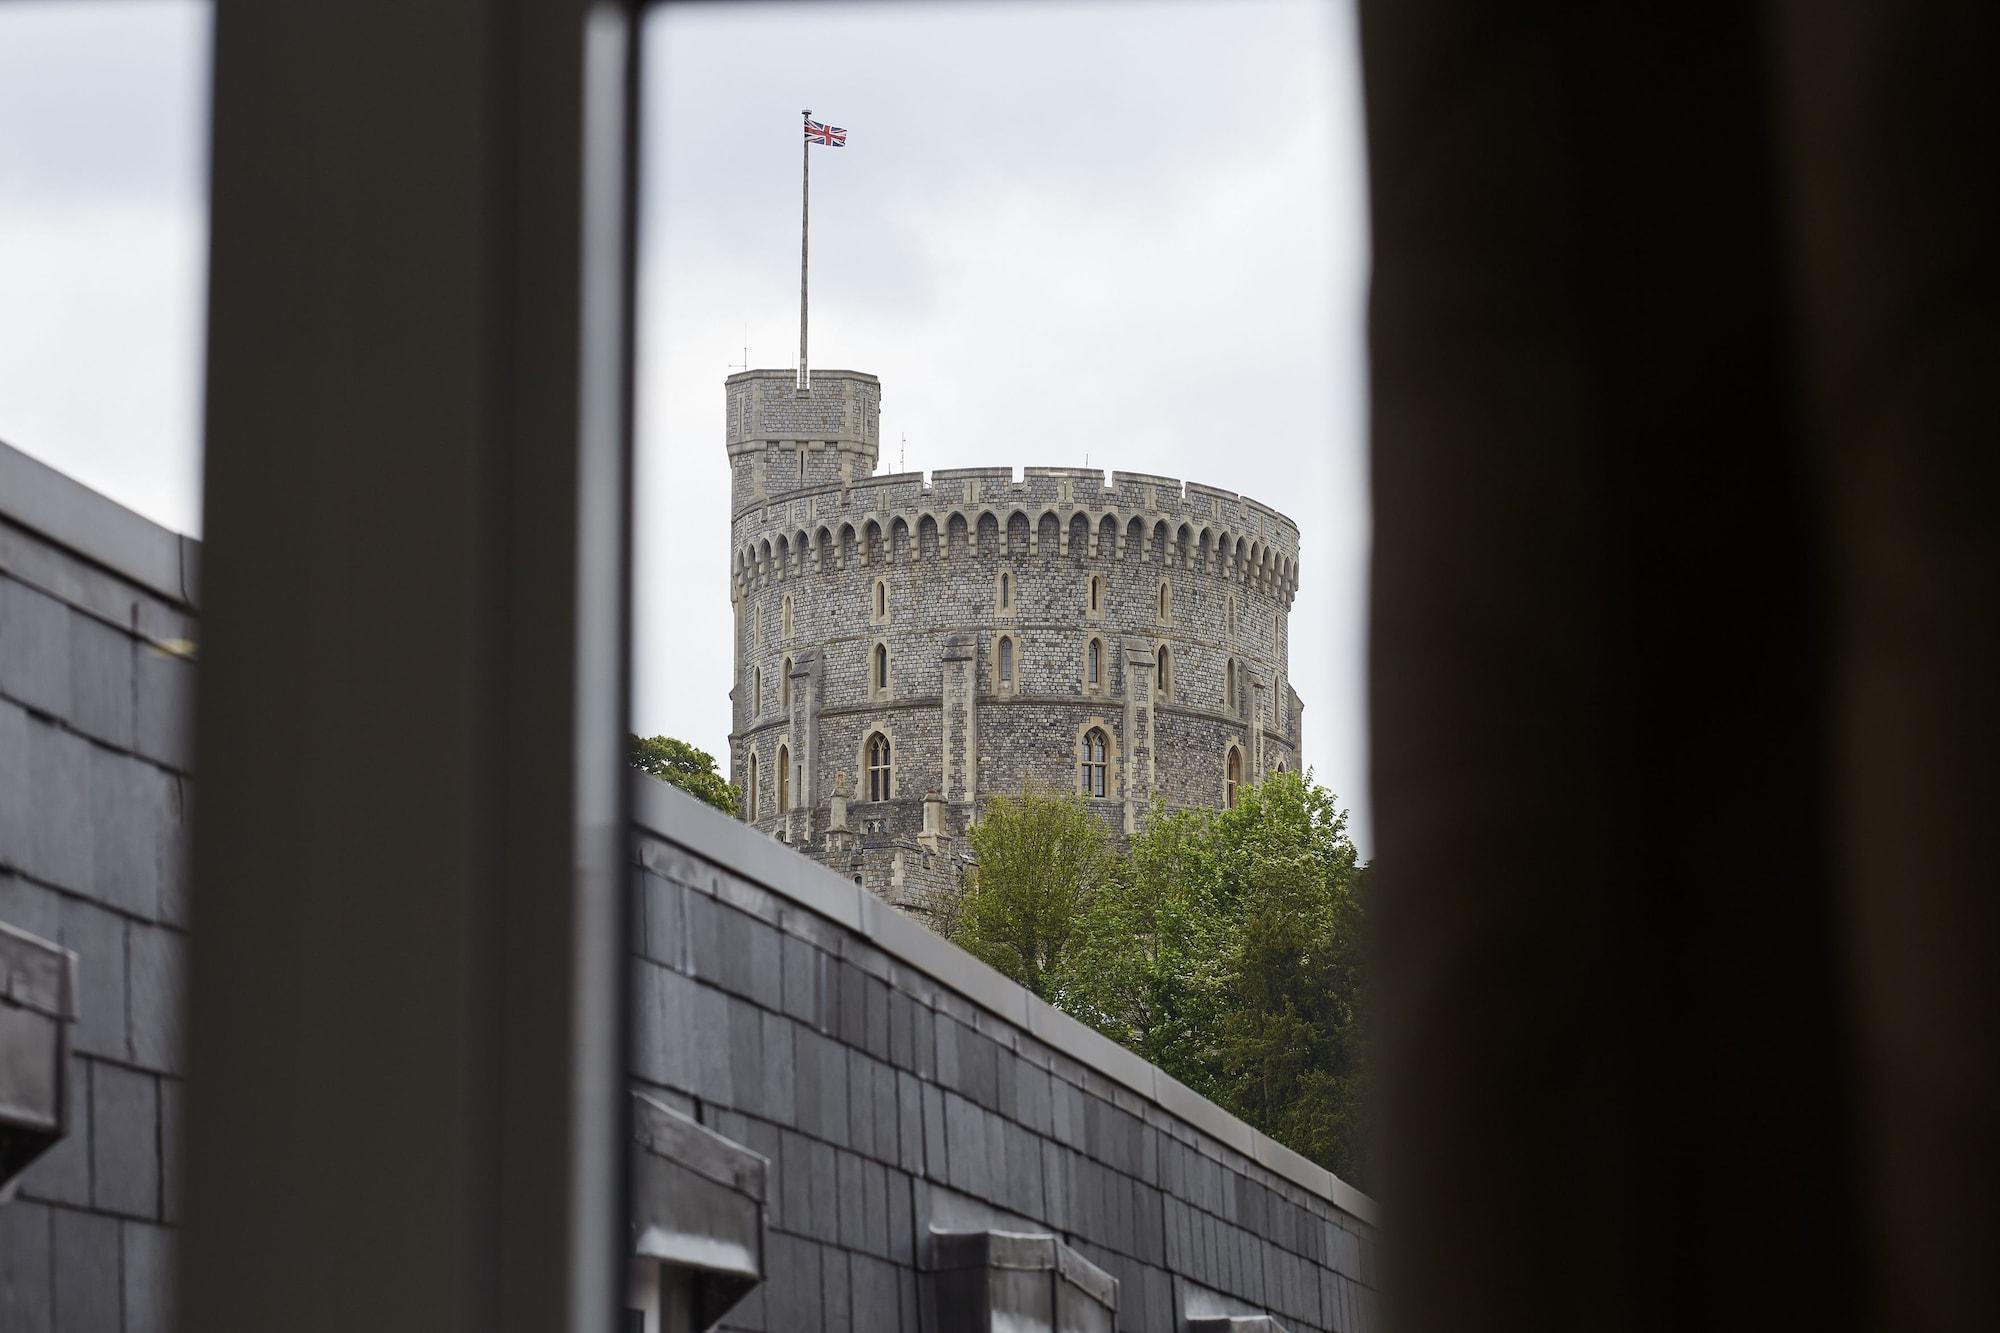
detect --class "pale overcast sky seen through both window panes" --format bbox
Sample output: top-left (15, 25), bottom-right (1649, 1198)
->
top-left (0, 0), bottom-right (1372, 853)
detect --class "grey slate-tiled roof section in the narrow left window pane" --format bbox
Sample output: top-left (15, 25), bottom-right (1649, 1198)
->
top-left (0, 480), bottom-right (196, 1333)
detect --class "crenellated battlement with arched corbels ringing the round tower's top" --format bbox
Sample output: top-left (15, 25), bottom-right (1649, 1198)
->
top-left (730, 468), bottom-right (1298, 602)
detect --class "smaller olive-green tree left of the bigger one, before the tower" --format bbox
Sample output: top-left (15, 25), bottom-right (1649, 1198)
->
top-left (948, 789), bottom-right (1114, 1003)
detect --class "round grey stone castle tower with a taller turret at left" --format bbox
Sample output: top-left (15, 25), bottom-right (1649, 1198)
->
top-left (726, 370), bottom-right (1302, 913)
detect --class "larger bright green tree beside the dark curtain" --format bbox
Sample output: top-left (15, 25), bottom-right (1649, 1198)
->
top-left (1058, 775), bottom-right (1366, 1183)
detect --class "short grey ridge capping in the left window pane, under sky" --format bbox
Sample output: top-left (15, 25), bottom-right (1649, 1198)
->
top-left (0, 442), bottom-right (202, 606)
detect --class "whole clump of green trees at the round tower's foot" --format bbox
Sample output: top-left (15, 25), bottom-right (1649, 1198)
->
top-left (954, 773), bottom-right (1368, 1185)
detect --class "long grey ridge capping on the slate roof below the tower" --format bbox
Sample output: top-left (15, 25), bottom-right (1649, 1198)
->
top-left (632, 773), bottom-right (1380, 1227)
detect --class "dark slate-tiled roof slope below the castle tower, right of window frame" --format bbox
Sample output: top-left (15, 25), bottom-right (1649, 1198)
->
top-left (632, 793), bottom-right (1376, 1333)
